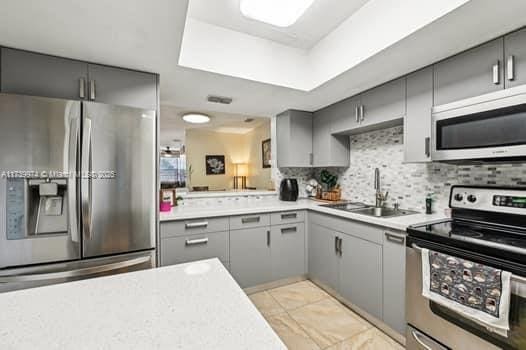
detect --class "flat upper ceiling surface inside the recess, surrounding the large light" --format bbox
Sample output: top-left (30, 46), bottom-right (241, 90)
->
top-left (188, 0), bottom-right (369, 49)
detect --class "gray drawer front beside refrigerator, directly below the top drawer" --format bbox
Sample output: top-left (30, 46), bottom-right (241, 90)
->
top-left (161, 231), bottom-right (229, 266)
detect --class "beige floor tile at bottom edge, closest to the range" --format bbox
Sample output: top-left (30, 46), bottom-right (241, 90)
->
top-left (327, 328), bottom-right (404, 350)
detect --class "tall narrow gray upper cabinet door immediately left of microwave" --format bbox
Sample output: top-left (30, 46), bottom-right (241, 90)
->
top-left (404, 68), bottom-right (433, 162)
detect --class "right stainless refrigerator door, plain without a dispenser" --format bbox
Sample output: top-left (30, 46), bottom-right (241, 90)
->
top-left (81, 102), bottom-right (156, 257)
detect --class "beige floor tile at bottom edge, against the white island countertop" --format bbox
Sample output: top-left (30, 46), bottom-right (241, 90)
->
top-left (267, 313), bottom-right (320, 350)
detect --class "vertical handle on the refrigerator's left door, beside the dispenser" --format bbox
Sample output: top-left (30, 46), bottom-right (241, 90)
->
top-left (68, 118), bottom-right (80, 243)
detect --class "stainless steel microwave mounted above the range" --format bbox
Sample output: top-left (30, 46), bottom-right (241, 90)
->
top-left (431, 86), bottom-right (526, 162)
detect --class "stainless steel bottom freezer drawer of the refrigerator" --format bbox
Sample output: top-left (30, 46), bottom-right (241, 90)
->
top-left (0, 250), bottom-right (155, 293)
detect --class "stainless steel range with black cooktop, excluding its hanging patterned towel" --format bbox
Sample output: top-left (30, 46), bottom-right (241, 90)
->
top-left (406, 186), bottom-right (526, 350)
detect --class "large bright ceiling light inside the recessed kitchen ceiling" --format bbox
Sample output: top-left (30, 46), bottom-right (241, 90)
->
top-left (239, 0), bottom-right (314, 27)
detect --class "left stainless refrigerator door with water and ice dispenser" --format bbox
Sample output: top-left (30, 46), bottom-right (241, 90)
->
top-left (0, 94), bottom-right (80, 269)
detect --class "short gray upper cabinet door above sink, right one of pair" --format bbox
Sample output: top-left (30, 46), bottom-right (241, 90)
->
top-left (360, 78), bottom-right (405, 127)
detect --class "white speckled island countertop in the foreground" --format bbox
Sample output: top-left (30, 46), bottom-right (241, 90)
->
top-left (0, 259), bottom-right (286, 350)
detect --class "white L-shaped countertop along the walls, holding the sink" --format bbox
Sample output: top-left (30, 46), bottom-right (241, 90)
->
top-left (160, 198), bottom-right (446, 231)
